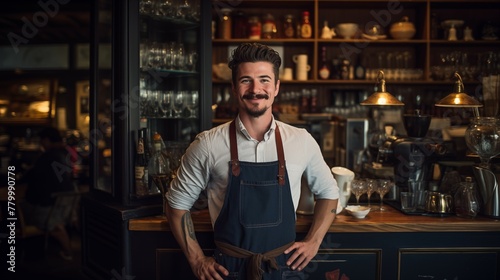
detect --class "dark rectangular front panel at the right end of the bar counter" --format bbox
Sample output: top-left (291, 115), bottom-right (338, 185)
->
top-left (398, 248), bottom-right (500, 279)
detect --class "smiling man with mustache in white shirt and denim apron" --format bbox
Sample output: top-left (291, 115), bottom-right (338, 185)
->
top-left (166, 43), bottom-right (339, 280)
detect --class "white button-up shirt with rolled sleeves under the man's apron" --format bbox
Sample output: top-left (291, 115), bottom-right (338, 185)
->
top-left (166, 118), bottom-right (339, 224)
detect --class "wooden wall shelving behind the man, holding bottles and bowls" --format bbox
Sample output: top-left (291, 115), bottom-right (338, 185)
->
top-left (212, 0), bottom-right (500, 115)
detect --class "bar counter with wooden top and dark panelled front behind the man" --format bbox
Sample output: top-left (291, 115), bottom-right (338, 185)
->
top-left (128, 205), bottom-right (500, 280)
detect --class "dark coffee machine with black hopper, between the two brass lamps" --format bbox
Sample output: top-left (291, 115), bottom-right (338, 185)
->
top-left (379, 110), bottom-right (446, 194)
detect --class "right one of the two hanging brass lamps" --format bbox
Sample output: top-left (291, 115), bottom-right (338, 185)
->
top-left (434, 72), bottom-right (483, 117)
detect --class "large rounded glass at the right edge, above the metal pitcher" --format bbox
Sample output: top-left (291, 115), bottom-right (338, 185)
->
top-left (465, 117), bottom-right (500, 168)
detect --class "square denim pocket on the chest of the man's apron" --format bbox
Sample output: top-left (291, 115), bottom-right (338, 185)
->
top-left (239, 180), bottom-right (283, 228)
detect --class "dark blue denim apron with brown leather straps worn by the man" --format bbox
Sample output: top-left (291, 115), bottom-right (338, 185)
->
top-left (214, 121), bottom-right (300, 280)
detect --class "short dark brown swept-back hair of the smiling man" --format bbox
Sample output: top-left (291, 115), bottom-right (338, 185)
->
top-left (228, 43), bottom-right (281, 84)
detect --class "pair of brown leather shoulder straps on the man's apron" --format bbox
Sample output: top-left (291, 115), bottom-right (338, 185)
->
top-left (229, 120), bottom-right (285, 186)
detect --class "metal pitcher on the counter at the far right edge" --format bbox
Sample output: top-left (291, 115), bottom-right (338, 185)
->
top-left (473, 166), bottom-right (500, 218)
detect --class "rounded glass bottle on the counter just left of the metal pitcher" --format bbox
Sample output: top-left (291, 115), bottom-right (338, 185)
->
top-left (454, 177), bottom-right (479, 218)
